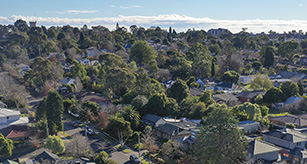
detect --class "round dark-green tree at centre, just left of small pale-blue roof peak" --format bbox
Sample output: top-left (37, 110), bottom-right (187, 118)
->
top-left (168, 79), bottom-right (190, 102)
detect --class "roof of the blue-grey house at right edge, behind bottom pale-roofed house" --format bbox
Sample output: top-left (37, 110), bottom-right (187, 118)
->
top-left (262, 129), bottom-right (307, 143)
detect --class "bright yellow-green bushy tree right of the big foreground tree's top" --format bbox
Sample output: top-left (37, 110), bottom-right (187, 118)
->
top-left (231, 102), bottom-right (262, 121)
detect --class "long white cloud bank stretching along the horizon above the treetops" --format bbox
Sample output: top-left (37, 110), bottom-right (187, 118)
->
top-left (0, 14), bottom-right (307, 33)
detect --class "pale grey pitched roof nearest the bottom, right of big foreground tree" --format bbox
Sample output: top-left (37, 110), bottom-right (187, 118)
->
top-left (248, 140), bottom-right (282, 155)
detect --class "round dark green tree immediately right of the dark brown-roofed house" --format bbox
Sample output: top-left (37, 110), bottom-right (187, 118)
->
top-left (263, 87), bottom-right (284, 103)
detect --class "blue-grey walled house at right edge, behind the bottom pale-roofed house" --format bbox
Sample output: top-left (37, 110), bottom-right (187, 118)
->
top-left (262, 129), bottom-right (307, 149)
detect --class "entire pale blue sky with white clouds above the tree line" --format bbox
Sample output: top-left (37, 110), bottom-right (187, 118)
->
top-left (0, 0), bottom-right (307, 33)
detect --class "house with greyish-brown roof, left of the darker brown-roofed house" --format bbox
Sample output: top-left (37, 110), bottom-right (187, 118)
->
top-left (212, 93), bottom-right (239, 106)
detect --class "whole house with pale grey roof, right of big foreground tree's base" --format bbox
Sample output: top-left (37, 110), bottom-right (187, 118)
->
top-left (248, 140), bottom-right (282, 162)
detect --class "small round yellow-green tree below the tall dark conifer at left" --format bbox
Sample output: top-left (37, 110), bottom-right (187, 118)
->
top-left (44, 135), bottom-right (65, 154)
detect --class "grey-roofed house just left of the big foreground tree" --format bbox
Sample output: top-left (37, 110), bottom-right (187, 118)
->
top-left (155, 120), bottom-right (197, 139)
